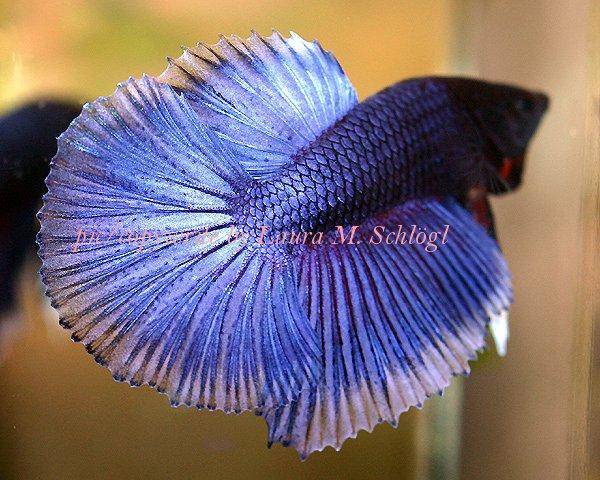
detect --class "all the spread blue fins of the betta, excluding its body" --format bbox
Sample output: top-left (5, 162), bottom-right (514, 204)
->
top-left (38, 32), bottom-right (511, 458)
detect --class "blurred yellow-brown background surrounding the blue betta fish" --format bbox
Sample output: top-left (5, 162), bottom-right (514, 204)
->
top-left (0, 0), bottom-right (588, 480)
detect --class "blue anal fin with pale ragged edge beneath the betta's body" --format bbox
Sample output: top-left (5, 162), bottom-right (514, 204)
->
top-left (264, 200), bottom-right (511, 458)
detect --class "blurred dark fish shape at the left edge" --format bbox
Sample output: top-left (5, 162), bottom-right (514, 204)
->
top-left (0, 100), bottom-right (81, 315)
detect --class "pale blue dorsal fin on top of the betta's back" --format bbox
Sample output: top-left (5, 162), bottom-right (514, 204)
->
top-left (159, 31), bottom-right (357, 178)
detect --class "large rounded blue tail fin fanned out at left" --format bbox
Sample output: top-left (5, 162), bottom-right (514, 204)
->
top-left (38, 77), bottom-right (320, 411)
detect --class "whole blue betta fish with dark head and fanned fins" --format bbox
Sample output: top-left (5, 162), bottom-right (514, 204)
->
top-left (38, 32), bottom-right (548, 458)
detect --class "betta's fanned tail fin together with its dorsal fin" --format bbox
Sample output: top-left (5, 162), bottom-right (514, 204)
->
top-left (38, 33), bottom-right (356, 412)
